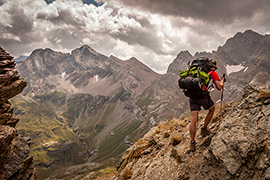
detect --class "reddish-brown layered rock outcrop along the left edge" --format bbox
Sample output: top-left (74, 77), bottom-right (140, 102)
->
top-left (0, 48), bottom-right (37, 180)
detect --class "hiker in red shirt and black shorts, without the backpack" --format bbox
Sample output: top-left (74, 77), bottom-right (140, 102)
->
top-left (189, 60), bottom-right (227, 151)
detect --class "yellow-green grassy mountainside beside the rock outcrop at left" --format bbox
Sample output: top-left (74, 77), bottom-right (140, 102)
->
top-left (11, 92), bottom-right (86, 179)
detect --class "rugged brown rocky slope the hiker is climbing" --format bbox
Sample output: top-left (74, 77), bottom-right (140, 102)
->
top-left (113, 74), bottom-right (270, 180)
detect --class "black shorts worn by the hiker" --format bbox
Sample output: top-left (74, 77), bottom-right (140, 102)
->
top-left (189, 96), bottom-right (214, 111)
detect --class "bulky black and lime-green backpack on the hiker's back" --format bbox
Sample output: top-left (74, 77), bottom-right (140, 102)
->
top-left (178, 57), bottom-right (214, 98)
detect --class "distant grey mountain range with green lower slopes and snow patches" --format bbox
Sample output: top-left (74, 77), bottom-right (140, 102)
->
top-left (12, 30), bottom-right (270, 177)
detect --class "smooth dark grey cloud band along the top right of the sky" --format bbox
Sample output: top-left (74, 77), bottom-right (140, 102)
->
top-left (120, 0), bottom-right (270, 24)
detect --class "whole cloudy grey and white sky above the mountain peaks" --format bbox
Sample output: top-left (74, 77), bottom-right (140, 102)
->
top-left (0, 0), bottom-right (270, 73)
